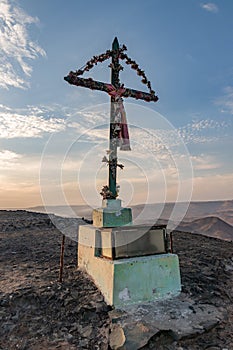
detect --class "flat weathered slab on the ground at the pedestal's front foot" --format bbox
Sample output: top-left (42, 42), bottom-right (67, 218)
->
top-left (109, 294), bottom-right (225, 350)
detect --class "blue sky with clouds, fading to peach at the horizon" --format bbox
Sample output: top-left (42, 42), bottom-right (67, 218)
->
top-left (0, 0), bottom-right (233, 209)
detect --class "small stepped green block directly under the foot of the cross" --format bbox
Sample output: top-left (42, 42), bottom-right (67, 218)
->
top-left (92, 199), bottom-right (132, 227)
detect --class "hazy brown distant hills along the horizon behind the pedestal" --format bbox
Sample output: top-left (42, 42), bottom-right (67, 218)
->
top-left (28, 200), bottom-right (233, 241)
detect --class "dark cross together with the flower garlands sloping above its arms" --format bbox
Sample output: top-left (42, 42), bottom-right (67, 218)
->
top-left (64, 38), bottom-right (158, 199)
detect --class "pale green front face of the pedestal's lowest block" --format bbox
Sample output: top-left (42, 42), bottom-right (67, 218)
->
top-left (112, 254), bottom-right (181, 307)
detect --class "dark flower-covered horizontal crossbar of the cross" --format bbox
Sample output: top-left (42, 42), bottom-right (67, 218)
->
top-left (64, 72), bottom-right (159, 102)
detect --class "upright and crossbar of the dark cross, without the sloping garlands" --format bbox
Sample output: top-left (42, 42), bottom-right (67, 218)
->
top-left (64, 38), bottom-right (158, 198)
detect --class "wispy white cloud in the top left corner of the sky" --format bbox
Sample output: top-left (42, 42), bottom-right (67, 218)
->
top-left (0, 0), bottom-right (46, 89)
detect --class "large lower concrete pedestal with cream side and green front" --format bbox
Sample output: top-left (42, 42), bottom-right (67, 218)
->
top-left (78, 225), bottom-right (181, 308)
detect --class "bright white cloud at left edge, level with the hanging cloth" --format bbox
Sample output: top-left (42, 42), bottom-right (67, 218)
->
top-left (0, 105), bottom-right (65, 139)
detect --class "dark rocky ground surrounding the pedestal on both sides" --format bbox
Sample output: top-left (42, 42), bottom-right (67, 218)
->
top-left (0, 211), bottom-right (233, 350)
